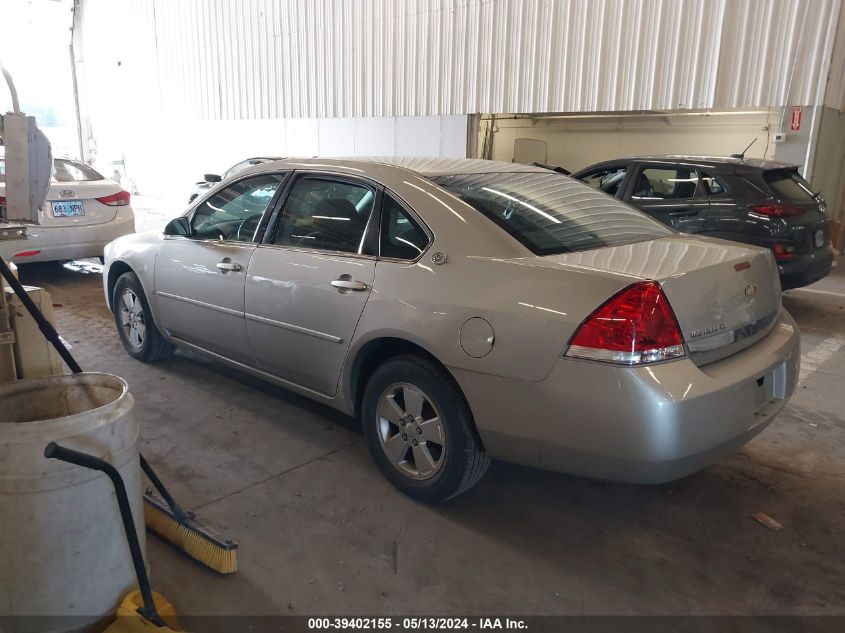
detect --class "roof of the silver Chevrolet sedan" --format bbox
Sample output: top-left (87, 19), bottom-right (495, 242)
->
top-left (256, 156), bottom-right (549, 177)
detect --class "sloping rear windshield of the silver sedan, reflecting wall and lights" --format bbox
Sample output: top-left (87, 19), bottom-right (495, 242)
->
top-left (431, 173), bottom-right (673, 255)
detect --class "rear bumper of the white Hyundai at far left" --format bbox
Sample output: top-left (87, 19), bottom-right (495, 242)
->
top-left (0, 214), bottom-right (135, 264)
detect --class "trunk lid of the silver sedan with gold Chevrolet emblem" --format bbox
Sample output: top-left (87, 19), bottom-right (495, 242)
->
top-left (539, 235), bottom-right (780, 365)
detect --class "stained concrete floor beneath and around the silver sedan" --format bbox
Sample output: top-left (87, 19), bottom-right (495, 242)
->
top-left (14, 254), bottom-right (845, 615)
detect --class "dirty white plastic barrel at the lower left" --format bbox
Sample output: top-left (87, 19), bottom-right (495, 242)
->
top-left (0, 373), bottom-right (146, 630)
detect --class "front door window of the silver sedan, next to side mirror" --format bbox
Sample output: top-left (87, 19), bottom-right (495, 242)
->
top-left (191, 174), bottom-right (284, 242)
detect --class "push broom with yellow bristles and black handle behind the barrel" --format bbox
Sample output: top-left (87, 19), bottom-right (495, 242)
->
top-left (0, 257), bottom-right (238, 574)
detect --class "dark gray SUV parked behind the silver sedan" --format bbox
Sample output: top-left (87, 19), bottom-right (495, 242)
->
top-left (572, 156), bottom-right (833, 290)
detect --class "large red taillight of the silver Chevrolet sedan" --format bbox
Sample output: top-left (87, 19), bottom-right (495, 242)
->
top-left (566, 281), bottom-right (685, 365)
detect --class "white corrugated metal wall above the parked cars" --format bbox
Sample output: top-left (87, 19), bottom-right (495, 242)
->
top-left (79, 0), bottom-right (845, 119)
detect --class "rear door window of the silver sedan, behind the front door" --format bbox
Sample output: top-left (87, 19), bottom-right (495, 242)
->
top-left (273, 177), bottom-right (375, 253)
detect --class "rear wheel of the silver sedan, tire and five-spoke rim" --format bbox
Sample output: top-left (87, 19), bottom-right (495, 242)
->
top-left (361, 355), bottom-right (490, 503)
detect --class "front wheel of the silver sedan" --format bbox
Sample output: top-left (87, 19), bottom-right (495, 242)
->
top-left (112, 273), bottom-right (176, 363)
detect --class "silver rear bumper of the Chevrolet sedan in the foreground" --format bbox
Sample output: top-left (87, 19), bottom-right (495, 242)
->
top-left (454, 311), bottom-right (800, 484)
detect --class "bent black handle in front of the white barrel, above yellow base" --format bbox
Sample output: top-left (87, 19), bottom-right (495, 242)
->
top-left (44, 442), bottom-right (164, 626)
